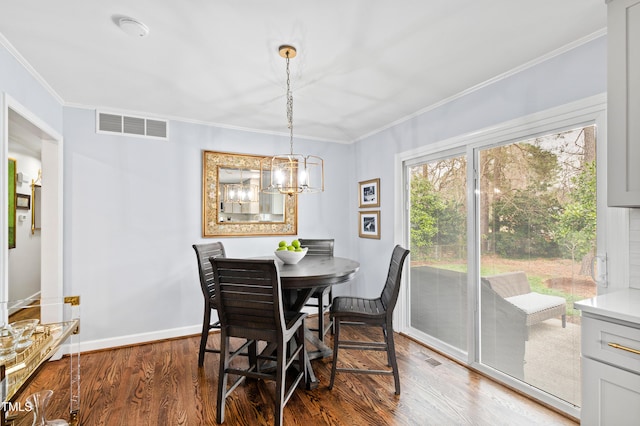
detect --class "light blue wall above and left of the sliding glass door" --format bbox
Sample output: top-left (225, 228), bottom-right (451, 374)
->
top-left (355, 37), bottom-right (607, 296)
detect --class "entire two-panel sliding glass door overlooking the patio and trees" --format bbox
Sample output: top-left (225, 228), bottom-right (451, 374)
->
top-left (405, 126), bottom-right (597, 407)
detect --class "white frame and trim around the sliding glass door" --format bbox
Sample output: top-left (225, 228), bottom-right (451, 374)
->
top-left (394, 94), bottom-right (629, 418)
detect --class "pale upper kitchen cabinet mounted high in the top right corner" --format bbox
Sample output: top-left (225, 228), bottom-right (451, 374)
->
top-left (607, 0), bottom-right (640, 207)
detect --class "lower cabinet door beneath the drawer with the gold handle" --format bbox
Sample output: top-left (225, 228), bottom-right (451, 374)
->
top-left (580, 358), bottom-right (640, 426)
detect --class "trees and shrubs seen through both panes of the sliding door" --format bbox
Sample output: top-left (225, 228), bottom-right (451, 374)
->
top-left (410, 126), bottom-right (596, 274)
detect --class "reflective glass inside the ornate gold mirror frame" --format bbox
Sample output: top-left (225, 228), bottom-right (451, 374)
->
top-left (218, 166), bottom-right (285, 223)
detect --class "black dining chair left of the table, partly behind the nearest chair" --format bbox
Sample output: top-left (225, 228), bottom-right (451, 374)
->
top-left (193, 242), bottom-right (226, 367)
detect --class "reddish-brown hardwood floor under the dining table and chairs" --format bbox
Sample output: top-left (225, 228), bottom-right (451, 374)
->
top-left (8, 320), bottom-right (577, 426)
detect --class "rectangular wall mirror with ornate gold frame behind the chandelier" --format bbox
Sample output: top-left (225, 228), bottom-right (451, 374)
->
top-left (202, 151), bottom-right (298, 238)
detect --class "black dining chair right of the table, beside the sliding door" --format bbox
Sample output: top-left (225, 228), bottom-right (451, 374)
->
top-left (329, 245), bottom-right (409, 395)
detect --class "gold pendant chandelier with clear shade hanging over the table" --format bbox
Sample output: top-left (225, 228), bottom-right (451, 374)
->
top-left (260, 45), bottom-right (324, 195)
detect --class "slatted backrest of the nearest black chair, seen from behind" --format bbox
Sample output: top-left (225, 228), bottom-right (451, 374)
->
top-left (211, 258), bottom-right (285, 336)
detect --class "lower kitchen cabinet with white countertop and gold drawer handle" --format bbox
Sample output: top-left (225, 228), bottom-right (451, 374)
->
top-left (574, 289), bottom-right (640, 426)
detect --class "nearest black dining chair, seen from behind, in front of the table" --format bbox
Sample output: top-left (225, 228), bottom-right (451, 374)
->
top-left (211, 257), bottom-right (307, 425)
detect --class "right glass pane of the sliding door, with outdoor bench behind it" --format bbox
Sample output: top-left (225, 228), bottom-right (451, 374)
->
top-left (478, 126), bottom-right (596, 406)
